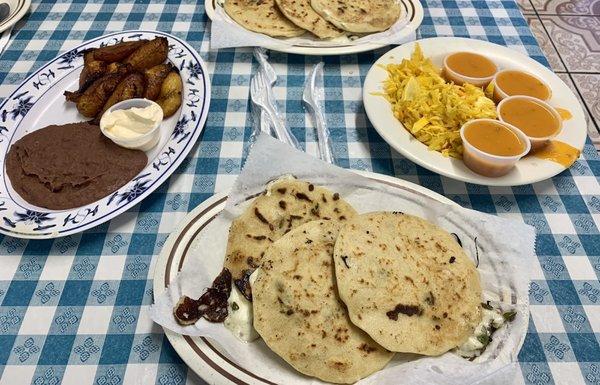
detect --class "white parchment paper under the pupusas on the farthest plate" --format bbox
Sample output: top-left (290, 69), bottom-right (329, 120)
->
top-left (210, 1), bottom-right (416, 49)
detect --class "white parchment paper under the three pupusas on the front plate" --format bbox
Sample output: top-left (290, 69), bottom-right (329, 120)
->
top-left (151, 134), bottom-right (535, 385)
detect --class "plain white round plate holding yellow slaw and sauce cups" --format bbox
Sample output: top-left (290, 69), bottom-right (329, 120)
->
top-left (363, 37), bottom-right (587, 186)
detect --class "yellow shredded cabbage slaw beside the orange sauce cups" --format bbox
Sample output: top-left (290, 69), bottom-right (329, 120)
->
top-left (384, 44), bottom-right (496, 159)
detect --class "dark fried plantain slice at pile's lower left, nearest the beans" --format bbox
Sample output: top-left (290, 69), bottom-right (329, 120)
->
top-left (73, 66), bottom-right (129, 118)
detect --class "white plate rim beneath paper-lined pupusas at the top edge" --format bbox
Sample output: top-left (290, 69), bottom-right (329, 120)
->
top-left (204, 0), bottom-right (424, 56)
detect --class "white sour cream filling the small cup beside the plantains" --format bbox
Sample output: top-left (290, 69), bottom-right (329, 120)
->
top-left (101, 104), bottom-right (163, 140)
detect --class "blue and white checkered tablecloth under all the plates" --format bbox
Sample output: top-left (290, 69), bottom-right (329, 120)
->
top-left (0, 0), bottom-right (600, 385)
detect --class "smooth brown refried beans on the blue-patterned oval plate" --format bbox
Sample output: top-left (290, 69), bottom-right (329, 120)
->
top-left (5, 123), bottom-right (148, 210)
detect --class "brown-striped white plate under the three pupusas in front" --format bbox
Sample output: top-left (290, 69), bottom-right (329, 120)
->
top-left (153, 171), bottom-right (456, 385)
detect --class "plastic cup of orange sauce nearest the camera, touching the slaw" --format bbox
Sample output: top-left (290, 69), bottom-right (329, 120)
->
top-left (460, 119), bottom-right (531, 177)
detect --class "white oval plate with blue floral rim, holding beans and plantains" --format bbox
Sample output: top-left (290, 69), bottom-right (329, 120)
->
top-left (0, 31), bottom-right (210, 238)
